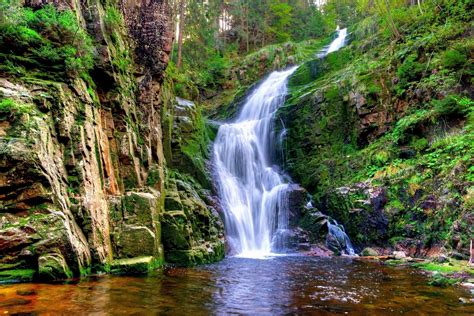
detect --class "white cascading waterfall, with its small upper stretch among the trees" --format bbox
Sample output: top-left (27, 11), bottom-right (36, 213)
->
top-left (214, 29), bottom-right (347, 257)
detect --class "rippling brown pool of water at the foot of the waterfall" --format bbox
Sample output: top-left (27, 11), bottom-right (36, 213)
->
top-left (0, 256), bottom-right (474, 315)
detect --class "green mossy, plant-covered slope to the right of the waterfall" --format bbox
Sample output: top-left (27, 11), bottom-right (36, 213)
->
top-left (280, 1), bottom-right (474, 259)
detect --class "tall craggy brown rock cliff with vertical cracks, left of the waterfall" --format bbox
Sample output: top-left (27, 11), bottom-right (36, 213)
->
top-left (0, 0), bottom-right (223, 280)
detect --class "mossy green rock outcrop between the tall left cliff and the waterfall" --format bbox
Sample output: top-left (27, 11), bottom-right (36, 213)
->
top-left (162, 98), bottom-right (224, 265)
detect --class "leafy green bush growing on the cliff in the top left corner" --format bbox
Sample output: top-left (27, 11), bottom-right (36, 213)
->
top-left (0, 0), bottom-right (94, 78)
